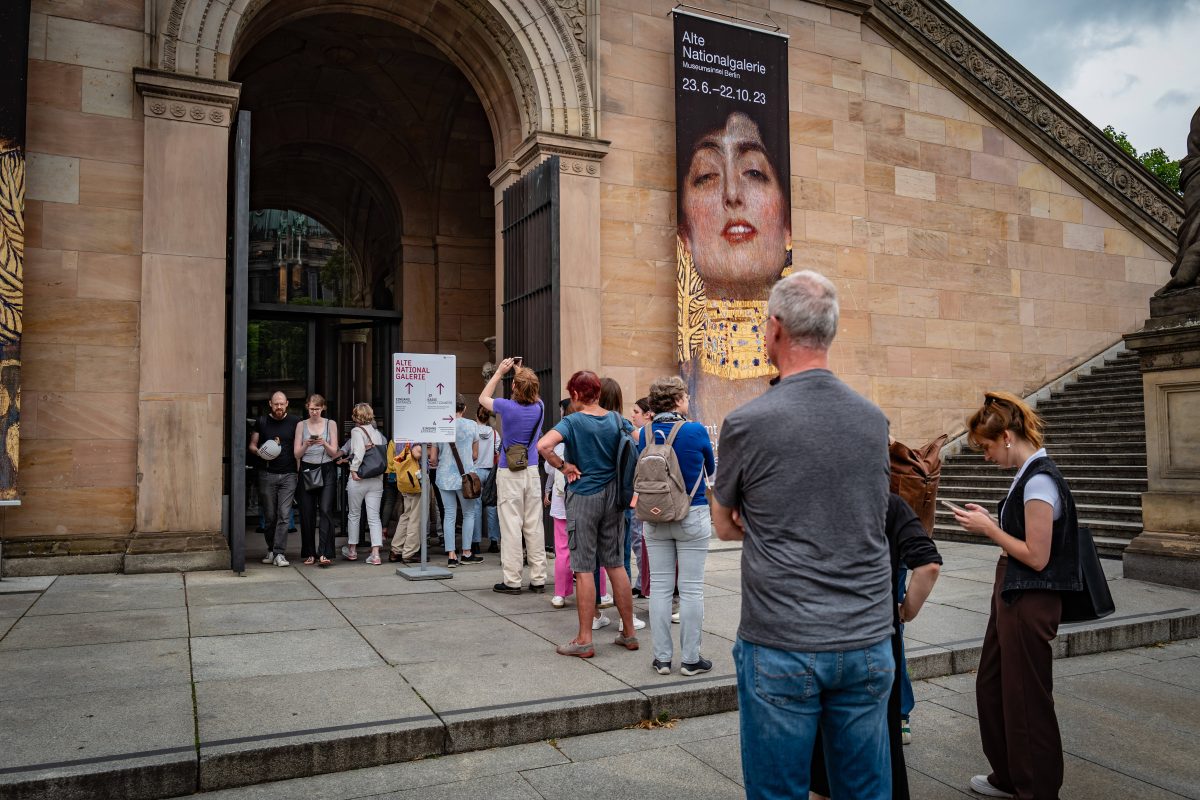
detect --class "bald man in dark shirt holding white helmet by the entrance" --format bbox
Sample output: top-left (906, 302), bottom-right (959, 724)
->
top-left (250, 392), bottom-right (300, 566)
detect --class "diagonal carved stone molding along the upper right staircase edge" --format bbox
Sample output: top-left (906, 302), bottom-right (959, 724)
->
top-left (871, 0), bottom-right (1183, 257)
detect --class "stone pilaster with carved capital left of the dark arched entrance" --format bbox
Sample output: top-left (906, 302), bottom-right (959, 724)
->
top-left (125, 68), bottom-right (240, 572)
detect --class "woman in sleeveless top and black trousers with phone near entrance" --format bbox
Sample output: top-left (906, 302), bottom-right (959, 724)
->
top-left (295, 395), bottom-right (337, 566)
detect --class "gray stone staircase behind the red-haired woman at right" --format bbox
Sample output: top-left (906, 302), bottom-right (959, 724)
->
top-left (934, 351), bottom-right (1146, 555)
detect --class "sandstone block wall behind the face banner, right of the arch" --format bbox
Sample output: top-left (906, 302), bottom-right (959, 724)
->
top-left (600, 0), bottom-right (1169, 443)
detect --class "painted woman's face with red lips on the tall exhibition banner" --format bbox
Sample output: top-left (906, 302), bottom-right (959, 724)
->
top-left (679, 112), bottom-right (792, 299)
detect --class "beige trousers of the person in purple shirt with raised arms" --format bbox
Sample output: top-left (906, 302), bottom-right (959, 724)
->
top-left (496, 464), bottom-right (546, 587)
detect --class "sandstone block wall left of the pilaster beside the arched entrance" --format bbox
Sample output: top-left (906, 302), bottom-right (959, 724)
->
top-left (10, 0), bottom-right (144, 552)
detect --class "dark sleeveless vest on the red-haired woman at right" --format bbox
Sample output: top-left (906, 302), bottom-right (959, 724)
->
top-left (998, 458), bottom-right (1084, 606)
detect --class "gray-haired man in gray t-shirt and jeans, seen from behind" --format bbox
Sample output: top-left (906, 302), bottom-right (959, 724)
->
top-left (713, 271), bottom-right (895, 800)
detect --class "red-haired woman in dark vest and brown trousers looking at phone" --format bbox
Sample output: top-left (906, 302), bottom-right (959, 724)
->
top-left (953, 392), bottom-right (1081, 800)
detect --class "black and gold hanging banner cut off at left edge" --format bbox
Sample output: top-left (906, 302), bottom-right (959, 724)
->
top-left (0, 0), bottom-right (30, 504)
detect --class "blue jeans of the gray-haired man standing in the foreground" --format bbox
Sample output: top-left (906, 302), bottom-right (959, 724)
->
top-left (734, 633), bottom-right (895, 800)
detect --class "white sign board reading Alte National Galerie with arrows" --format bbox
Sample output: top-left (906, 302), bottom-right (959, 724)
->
top-left (391, 353), bottom-right (457, 441)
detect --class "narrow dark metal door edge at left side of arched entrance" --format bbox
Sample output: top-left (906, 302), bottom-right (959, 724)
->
top-left (224, 110), bottom-right (250, 575)
